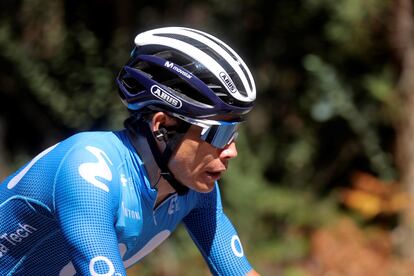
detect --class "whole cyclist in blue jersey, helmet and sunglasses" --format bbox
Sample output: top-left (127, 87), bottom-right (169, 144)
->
top-left (0, 27), bottom-right (257, 275)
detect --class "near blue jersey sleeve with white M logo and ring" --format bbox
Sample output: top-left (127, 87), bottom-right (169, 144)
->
top-left (55, 145), bottom-right (126, 275)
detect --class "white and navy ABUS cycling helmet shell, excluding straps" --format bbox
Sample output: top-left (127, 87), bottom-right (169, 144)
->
top-left (117, 27), bottom-right (256, 119)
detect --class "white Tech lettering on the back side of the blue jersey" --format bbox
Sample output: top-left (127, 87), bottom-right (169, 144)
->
top-left (0, 223), bottom-right (37, 258)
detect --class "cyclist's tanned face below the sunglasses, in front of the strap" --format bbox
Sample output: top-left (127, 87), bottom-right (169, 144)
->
top-left (169, 125), bottom-right (237, 193)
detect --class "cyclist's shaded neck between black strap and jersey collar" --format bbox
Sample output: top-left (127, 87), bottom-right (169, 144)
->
top-left (131, 130), bottom-right (175, 207)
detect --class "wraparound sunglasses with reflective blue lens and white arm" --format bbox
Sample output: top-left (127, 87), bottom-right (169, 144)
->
top-left (172, 113), bottom-right (240, 149)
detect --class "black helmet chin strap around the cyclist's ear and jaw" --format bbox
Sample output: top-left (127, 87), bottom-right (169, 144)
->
top-left (124, 115), bottom-right (190, 195)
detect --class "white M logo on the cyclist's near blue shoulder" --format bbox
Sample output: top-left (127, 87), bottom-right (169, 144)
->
top-left (78, 146), bottom-right (112, 192)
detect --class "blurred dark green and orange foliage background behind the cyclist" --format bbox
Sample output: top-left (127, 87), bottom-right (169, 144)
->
top-left (0, 0), bottom-right (414, 275)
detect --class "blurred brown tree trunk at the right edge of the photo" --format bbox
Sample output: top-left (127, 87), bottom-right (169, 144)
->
top-left (391, 0), bottom-right (414, 260)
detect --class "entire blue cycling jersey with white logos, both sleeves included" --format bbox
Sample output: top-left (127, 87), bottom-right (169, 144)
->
top-left (0, 130), bottom-right (251, 276)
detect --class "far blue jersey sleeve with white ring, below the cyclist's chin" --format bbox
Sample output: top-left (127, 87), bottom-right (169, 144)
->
top-left (184, 185), bottom-right (252, 275)
